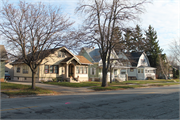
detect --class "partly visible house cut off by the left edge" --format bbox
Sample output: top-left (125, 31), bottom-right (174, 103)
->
top-left (0, 45), bottom-right (8, 82)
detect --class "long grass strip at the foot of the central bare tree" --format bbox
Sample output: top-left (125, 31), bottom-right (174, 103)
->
top-left (44, 79), bottom-right (179, 91)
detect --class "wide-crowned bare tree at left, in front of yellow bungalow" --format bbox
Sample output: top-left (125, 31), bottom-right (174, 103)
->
top-left (0, 1), bottom-right (73, 89)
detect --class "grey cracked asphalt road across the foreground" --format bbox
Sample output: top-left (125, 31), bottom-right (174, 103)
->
top-left (1, 85), bottom-right (180, 119)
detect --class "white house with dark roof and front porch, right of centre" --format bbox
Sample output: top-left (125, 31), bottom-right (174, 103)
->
top-left (118, 52), bottom-right (156, 80)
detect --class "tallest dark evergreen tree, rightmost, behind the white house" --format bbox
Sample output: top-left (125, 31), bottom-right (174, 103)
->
top-left (144, 25), bottom-right (163, 68)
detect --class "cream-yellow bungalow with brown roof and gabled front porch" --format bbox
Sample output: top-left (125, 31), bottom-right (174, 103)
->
top-left (12, 47), bottom-right (92, 82)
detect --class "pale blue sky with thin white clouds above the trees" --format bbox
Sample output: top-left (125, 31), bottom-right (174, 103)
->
top-left (0, 0), bottom-right (180, 54)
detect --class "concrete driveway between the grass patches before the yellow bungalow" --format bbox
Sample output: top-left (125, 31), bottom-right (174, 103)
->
top-left (1, 81), bottom-right (94, 98)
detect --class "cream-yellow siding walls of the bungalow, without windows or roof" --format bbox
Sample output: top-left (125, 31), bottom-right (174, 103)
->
top-left (11, 49), bottom-right (88, 82)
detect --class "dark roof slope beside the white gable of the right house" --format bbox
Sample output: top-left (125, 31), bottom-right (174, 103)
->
top-left (125, 52), bottom-right (143, 66)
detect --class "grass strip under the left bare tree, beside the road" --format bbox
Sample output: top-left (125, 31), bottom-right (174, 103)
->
top-left (1, 82), bottom-right (57, 96)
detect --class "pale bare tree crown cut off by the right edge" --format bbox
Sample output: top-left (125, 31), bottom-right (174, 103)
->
top-left (170, 38), bottom-right (180, 64)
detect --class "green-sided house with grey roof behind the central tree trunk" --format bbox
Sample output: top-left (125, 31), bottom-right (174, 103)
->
top-left (79, 48), bottom-right (126, 82)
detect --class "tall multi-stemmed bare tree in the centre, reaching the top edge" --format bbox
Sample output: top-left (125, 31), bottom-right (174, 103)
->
top-left (76, 0), bottom-right (149, 87)
